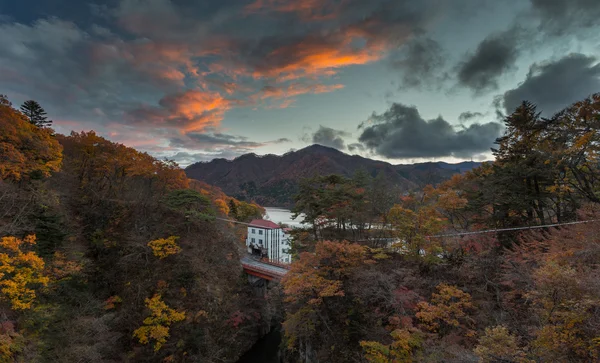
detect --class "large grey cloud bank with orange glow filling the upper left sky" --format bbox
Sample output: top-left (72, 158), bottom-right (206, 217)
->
top-left (0, 0), bottom-right (446, 140)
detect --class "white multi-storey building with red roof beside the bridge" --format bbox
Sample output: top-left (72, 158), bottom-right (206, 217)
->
top-left (246, 219), bottom-right (292, 263)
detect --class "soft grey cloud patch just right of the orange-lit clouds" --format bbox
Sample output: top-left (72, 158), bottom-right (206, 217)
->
top-left (392, 37), bottom-right (447, 88)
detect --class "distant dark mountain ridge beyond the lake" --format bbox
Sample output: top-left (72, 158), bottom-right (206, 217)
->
top-left (185, 145), bottom-right (480, 207)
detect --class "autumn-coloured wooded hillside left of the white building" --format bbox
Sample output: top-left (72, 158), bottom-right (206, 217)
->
top-left (0, 97), bottom-right (273, 362)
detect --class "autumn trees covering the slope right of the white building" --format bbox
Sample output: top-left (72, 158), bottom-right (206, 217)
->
top-left (283, 94), bottom-right (600, 363)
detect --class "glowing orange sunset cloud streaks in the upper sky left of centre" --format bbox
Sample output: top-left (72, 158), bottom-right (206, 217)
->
top-left (104, 0), bottom-right (404, 132)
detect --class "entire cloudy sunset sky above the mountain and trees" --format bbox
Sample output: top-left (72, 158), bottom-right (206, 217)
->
top-left (0, 0), bottom-right (600, 166)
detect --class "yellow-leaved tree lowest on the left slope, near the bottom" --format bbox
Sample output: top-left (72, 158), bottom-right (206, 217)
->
top-left (133, 294), bottom-right (185, 352)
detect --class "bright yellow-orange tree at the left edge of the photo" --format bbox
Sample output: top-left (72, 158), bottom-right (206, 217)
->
top-left (0, 235), bottom-right (49, 310)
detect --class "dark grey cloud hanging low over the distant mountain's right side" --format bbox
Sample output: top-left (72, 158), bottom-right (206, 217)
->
top-left (358, 103), bottom-right (502, 159)
